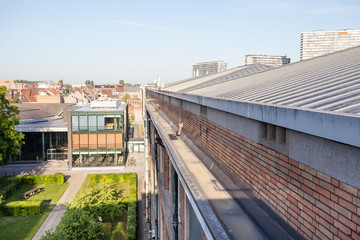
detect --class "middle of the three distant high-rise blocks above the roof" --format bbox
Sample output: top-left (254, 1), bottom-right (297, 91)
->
top-left (241, 54), bottom-right (290, 67)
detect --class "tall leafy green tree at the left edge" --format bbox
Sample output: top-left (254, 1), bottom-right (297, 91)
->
top-left (0, 86), bottom-right (24, 166)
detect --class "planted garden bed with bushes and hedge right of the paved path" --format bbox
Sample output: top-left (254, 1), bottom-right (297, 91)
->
top-left (42, 173), bottom-right (137, 240)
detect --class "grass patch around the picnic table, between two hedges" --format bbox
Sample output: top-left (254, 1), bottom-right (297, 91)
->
top-left (5, 182), bottom-right (69, 203)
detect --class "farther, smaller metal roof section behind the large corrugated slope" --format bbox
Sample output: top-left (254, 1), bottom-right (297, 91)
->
top-left (164, 64), bottom-right (273, 93)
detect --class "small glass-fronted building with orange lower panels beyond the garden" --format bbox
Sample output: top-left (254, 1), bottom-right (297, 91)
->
top-left (69, 100), bottom-right (128, 167)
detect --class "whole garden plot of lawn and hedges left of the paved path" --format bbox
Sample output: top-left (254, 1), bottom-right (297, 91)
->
top-left (0, 174), bottom-right (68, 240)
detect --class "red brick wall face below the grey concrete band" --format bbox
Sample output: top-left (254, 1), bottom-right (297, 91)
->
top-left (151, 94), bottom-right (360, 239)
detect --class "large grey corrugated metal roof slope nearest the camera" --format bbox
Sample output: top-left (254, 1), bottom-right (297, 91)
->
top-left (184, 47), bottom-right (360, 115)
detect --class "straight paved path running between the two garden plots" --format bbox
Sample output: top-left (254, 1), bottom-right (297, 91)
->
top-left (33, 173), bottom-right (86, 240)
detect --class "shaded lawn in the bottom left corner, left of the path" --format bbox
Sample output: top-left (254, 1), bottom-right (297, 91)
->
top-left (0, 205), bottom-right (55, 240)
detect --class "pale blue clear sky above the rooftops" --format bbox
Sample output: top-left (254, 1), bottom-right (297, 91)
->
top-left (0, 0), bottom-right (360, 84)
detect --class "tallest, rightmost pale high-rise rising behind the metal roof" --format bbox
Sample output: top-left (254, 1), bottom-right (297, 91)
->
top-left (300, 29), bottom-right (360, 60)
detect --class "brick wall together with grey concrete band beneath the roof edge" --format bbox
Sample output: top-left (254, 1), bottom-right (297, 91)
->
top-left (150, 90), bottom-right (360, 239)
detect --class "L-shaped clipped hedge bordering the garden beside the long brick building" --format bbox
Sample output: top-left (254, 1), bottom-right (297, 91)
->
top-left (89, 173), bottom-right (137, 240)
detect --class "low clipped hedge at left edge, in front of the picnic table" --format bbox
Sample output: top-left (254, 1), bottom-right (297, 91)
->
top-left (0, 200), bottom-right (42, 217)
